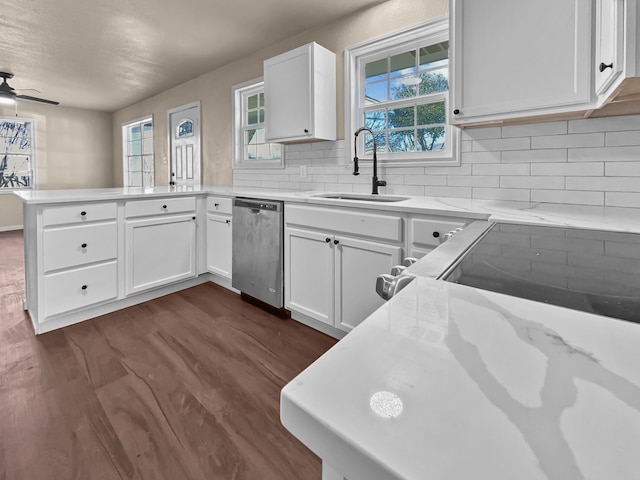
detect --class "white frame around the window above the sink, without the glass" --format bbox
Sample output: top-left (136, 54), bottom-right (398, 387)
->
top-left (344, 15), bottom-right (460, 167)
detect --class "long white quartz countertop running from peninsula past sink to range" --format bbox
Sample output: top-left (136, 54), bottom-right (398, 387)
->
top-left (14, 186), bottom-right (640, 232)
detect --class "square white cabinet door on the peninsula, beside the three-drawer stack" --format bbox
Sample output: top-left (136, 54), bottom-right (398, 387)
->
top-left (125, 215), bottom-right (196, 295)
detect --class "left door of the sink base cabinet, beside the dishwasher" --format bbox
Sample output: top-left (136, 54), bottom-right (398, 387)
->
top-left (284, 228), bottom-right (334, 326)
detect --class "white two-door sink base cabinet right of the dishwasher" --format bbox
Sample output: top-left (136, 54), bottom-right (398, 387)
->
top-left (285, 204), bottom-right (403, 332)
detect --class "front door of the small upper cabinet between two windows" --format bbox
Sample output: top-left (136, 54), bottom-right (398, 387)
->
top-left (264, 46), bottom-right (313, 141)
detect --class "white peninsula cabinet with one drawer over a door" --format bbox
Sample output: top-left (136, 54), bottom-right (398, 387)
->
top-left (125, 197), bottom-right (197, 295)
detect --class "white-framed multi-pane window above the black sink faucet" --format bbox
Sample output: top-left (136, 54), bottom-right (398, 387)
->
top-left (345, 17), bottom-right (458, 166)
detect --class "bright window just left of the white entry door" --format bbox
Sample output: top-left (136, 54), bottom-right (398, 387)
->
top-left (122, 117), bottom-right (155, 187)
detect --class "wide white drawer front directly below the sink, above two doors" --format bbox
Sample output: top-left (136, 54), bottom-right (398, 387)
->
top-left (284, 205), bottom-right (403, 242)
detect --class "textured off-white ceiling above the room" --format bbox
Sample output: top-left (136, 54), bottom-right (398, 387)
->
top-left (0, 0), bottom-right (381, 112)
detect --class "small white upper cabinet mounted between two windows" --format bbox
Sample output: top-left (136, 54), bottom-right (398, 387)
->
top-left (264, 42), bottom-right (336, 143)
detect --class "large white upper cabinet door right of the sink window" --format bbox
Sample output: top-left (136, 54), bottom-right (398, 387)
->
top-left (450, 0), bottom-right (592, 123)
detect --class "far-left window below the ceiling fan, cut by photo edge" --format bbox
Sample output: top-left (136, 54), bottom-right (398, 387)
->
top-left (0, 117), bottom-right (36, 190)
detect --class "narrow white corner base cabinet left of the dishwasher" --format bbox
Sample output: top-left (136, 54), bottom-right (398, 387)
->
top-left (207, 197), bottom-right (233, 279)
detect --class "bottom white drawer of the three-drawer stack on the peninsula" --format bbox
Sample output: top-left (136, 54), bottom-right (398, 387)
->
top-left (43, 261), bottom-right (118, 317)
